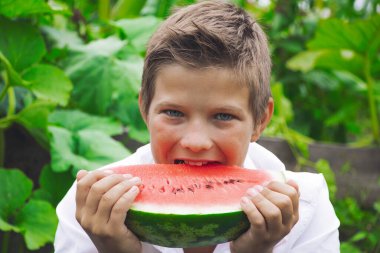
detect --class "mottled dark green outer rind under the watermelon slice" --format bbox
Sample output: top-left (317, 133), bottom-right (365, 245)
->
top-left (125, 209), bottom-right (250, 248)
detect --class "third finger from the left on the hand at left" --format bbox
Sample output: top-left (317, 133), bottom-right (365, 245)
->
top-left (97, 177), bottom-right (141, 222)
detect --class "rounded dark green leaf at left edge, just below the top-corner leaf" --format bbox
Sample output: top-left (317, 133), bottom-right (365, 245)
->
top-left (0, 16), bottom-right (46, 71)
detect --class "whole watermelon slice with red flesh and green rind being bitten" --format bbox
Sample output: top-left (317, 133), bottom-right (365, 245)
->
top-left (114, 164), bottom-right (285, 248)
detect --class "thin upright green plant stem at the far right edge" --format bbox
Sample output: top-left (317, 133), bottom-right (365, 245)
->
top-left (364, 55), bottom-right (380, 145)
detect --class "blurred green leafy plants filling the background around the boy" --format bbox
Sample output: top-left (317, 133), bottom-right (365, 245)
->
top-left (0, 0), bottom-right (380, 253)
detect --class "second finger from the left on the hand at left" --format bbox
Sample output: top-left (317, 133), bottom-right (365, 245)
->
top-left (84, 174), bottom-right (131, 215)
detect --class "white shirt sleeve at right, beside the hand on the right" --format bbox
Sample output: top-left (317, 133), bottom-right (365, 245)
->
top-left (274, 171), bottom-right (340, 253)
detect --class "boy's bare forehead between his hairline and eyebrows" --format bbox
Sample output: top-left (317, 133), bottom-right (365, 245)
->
top-left (152, 65), bottom-right (249, 109)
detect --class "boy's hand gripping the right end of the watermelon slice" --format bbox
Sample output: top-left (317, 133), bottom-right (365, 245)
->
top-left (230, 180), bottom-right (299, 253)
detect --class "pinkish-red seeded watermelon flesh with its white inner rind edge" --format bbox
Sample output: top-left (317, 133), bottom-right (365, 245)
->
top-left (111, 164), bottom-right (281, 213)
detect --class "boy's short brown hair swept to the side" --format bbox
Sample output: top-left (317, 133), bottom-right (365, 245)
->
top-left (141, 1), bottom-right (271, 126)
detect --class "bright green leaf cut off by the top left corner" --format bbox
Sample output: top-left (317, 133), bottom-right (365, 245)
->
top-left (0, 0), bottom-right (52, 18)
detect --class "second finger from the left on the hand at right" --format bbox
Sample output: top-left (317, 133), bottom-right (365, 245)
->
top-left (247, 185), bottom-right (282, 233)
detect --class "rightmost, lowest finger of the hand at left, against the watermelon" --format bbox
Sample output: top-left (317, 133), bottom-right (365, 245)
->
top-left (109, 185), bottom-right (140, 229)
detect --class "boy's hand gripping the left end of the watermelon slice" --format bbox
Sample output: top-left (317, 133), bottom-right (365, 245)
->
top-left (75, 170), bottom-right (141, 253)
